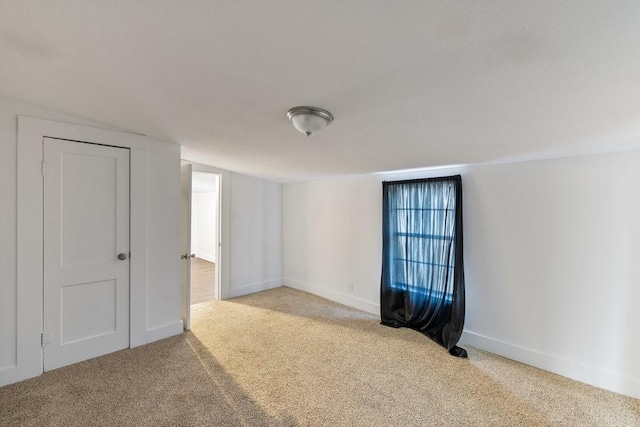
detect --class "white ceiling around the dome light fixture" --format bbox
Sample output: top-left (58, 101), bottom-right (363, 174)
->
top-left (0, 0), bottom-right (640, 181)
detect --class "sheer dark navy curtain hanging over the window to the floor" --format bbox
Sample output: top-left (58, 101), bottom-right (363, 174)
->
top-left (380, 175), bottom-right (467, 357)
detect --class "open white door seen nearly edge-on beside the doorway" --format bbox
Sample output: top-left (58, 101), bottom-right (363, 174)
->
top-left (180, 165), bottom-right (193, 330)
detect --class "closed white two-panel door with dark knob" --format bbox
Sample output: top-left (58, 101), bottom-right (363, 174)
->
top-left (43, 138), bottom-right (129, 371)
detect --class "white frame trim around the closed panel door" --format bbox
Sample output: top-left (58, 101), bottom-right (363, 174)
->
top-left (16, 116), bottom-right (149, 383)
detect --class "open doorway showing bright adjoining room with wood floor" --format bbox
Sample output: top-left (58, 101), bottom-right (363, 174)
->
top-left (191, 172), bottom-right (220, 305)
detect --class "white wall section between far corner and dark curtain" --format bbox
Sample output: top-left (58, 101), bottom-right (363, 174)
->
top-left (283, 176), bottom-right (382, 314)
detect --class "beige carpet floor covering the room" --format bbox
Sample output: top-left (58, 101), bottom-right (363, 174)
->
top-left (0, 287), bottom-right (640, 426)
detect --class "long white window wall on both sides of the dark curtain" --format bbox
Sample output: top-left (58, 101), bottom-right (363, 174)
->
top-left (283, 151), bottom-right (640, 397)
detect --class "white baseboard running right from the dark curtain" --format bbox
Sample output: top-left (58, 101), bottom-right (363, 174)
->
top-left (460, 331), bottom-right (640, 399)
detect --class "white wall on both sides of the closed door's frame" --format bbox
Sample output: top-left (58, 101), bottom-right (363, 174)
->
top-left (0, 97), bottom-right (180, 383)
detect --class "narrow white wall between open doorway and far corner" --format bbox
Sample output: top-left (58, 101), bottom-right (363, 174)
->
top-left (229, 173), bottom-right (282, 297)
